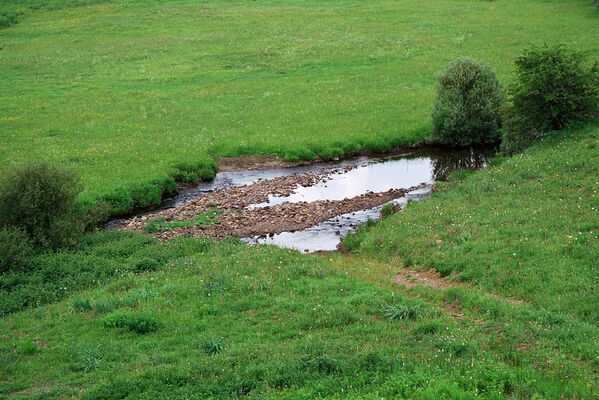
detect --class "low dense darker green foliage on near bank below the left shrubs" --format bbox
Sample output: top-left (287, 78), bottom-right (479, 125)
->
top-left (0, 231), bottom-right (219, 315)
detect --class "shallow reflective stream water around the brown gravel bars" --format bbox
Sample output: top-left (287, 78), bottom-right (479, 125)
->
top-left (108, 149), bottom-right (494, 252)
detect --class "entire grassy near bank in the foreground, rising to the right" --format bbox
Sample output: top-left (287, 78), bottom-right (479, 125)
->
top-left (0, 123), bottom-right (599, 399)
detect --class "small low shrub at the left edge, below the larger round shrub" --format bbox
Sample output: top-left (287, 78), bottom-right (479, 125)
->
top-left (0, 227), bottom-right (33, 274)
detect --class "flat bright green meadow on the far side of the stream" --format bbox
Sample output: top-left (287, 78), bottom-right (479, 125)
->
top-left (0, 0), bottom-right (599, 199)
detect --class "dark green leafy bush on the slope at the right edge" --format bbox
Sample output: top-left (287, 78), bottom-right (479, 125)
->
top-left (501, 46), bottom-right (599, 154)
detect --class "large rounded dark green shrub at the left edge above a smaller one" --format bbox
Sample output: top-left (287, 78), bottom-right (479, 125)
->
top-left (0, 161), bottom-right (83, 248)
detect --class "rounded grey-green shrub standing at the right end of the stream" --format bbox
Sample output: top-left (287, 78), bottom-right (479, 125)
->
top-left (430, 57), bottom-right (504, 147)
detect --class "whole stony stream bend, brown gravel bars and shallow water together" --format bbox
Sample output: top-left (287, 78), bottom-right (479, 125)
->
top-left (116, 150), bottom-right (491, 252)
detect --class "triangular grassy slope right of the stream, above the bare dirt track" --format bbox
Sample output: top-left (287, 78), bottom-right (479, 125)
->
top-left (344, 122), bottom-right (599, 324)
